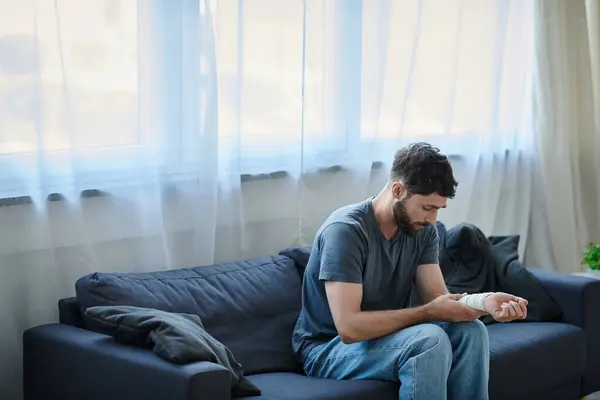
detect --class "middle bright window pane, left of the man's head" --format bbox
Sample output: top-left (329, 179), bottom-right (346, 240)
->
top-left (210, 0), bottom-right (360, 172)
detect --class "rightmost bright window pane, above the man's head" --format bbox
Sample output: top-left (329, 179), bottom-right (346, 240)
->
top-left (354, 1), bottom-right (532, 150)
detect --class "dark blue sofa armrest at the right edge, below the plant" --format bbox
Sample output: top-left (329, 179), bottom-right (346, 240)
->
top-left (529, 269), bottom-right (600, 395)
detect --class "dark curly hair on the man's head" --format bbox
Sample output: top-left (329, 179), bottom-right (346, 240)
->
top-left (390, 142), bottom-right (458, 199)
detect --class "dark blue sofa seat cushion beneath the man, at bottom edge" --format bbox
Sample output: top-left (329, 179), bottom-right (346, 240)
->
top-left (240, 372), bottom-right (400, 400)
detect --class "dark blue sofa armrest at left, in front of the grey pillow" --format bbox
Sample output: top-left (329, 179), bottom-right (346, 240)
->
top-left (23, 324), bottom-right (231, 400)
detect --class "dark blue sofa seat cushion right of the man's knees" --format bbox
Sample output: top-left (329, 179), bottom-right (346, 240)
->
top-left (488, 322), bottom-right (586, 398)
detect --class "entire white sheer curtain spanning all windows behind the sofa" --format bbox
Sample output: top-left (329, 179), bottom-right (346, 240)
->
top-left (0, 0), bottom-right (536, 398)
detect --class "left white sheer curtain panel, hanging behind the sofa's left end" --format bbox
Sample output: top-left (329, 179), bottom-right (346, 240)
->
top-left (0, 0), bottom-right (225, 399)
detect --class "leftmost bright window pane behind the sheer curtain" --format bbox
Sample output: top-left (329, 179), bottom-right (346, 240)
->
top-left (0, 0), bottom-right (139, 154)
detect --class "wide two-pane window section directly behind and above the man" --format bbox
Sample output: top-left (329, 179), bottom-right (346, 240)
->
top-left (211, 0), bottom-right (533, 172)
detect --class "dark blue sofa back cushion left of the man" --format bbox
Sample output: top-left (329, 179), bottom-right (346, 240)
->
top-left (75, 256), bottom-right (301, 374)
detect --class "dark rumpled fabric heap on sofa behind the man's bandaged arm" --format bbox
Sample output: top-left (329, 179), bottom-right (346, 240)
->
top-left (436, 222), bottom-right (562, 323)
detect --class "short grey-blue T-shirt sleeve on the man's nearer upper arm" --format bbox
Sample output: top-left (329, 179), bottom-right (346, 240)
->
top-left (319, 223), bottom-right (366, 283)
